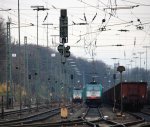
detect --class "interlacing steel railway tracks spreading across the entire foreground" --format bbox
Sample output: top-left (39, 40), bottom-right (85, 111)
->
top-left (0, 104), bottom-right (150, 127)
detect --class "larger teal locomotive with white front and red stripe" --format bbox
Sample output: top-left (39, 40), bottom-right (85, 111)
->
top-left (83, 81), bottom-right (102, 107)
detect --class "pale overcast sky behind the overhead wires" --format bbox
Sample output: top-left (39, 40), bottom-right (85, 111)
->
top-left (0, 0), bottom-right (150, 68)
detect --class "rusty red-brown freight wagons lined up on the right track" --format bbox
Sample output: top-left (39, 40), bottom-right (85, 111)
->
top-left (103, 82), bottom-right (147, 111)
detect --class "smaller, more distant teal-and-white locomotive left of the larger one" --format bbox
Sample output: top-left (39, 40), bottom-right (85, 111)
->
top-left (72, 88), bottom-right (83, 103)
